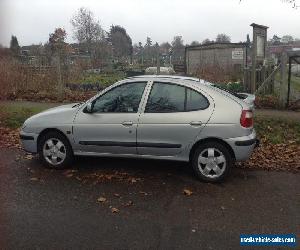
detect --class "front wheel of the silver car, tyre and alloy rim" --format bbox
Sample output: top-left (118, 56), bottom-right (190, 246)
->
top-left (38, 131), bottom-right (74, 169)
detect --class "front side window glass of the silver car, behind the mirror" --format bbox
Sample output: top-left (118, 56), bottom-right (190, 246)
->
top-left (93, 82), bottom-right (146, 113)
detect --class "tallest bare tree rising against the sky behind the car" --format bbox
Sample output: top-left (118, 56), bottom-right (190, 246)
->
top-left (71, 7), bottom-right (103, 54)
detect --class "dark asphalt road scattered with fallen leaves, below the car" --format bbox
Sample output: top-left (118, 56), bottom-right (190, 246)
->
top-left (0, 149), bottom-right (300, 249)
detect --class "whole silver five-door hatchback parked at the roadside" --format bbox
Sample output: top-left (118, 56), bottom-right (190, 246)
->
top-left (20, 75), bottom-right (257, 182)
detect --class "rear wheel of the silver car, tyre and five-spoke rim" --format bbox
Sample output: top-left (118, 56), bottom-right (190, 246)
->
top-left (192, 142), bottom-right (234, 183)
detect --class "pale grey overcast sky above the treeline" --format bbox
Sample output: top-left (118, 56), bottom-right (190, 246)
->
top-left (0, 0), bottom-right (300, 46)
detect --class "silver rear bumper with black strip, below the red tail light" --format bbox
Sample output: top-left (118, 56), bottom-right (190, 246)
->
top-left (225, 129), bottom-right (259, 161)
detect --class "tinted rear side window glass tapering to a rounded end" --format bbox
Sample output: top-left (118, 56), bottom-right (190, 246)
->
top-left (145, 83), bottom-right (209, 113)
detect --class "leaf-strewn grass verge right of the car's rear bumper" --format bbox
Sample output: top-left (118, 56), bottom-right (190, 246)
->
top-left (254, 116), bottom-right (300, 144)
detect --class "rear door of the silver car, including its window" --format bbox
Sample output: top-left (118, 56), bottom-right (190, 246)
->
top-left (137, 82), bottom-right (213, 156)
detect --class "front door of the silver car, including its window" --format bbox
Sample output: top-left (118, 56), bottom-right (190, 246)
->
top-left (73, 82), bottom-right (147, 154)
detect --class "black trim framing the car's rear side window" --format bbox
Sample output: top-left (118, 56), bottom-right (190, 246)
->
top-left (144, 81), bottom-right (210, 114)
